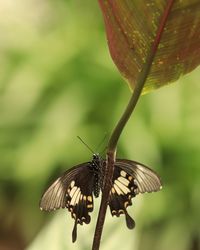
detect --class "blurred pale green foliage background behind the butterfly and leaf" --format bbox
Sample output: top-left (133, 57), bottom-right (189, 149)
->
top-left (0, 0), bottom-right (200, 250)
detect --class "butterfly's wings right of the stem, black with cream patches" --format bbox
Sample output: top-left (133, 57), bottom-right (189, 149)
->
top-left (109, 159), bottom-right (161, 229)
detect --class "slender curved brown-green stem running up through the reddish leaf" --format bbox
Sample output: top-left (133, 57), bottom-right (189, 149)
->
top-left (92, 0), bottom-right (175, 250)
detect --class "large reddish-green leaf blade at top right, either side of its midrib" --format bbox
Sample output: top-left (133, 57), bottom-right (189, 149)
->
top-left (99, 0), bottom-right (200, 93)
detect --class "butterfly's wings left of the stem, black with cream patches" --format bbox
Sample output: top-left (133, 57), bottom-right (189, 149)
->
top-left (40, 162), bottom-right (94, 242)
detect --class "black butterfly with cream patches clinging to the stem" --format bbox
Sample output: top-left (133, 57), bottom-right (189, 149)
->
top-left (40, 154), bottom-right (161, 242)
